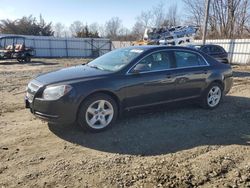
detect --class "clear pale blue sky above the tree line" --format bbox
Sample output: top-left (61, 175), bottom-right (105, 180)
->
top-left (0, 0), bottom-right (183, 29)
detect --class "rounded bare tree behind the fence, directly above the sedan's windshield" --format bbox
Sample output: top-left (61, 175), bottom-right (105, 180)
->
top-left (105, 17), bottom-right (122, 40)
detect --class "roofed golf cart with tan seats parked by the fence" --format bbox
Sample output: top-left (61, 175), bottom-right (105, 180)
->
top-left (0, 36), bottom-right (34, 62)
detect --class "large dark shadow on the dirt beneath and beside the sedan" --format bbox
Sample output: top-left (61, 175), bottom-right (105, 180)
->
top-left (48, 96), bottom-right (250, 156)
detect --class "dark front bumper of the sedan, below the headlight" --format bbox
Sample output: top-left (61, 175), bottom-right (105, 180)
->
top-left (25, 97), bottom-right (77, 124)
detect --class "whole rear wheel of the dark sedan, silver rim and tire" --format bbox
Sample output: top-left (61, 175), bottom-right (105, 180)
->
top-left (201, 83), bottom-right (223, 109)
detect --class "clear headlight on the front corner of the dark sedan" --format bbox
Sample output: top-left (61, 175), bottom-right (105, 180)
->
top-left (43, 85), bottom-right (72, 100)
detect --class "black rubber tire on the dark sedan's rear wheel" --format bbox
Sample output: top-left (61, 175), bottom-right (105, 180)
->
top-left (200, 82), bottom-right (223, 110)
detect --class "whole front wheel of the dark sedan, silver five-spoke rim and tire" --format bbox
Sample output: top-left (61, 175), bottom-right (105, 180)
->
top-left (77, 94), bottom-right (118, 132)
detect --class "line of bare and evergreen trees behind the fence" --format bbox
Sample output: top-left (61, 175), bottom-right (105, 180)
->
top-left (0, 0), bottom-right (250, 41)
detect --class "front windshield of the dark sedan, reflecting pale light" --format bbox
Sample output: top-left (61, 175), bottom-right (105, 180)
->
top-left (87, 48), bottom-right (143, 72)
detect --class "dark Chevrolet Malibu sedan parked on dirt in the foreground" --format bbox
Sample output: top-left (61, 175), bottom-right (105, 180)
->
top-left (25, 46), bottom-right (233, 132)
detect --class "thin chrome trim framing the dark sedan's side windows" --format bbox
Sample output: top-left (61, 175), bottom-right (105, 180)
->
top-left (126, 49), bottom-right (210, 75)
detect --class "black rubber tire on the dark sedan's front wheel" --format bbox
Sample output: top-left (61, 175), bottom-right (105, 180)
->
top-left (77, 93), bottom-right (118, 132)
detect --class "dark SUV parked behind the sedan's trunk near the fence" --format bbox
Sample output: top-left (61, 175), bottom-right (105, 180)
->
top-left (188, 44), bottom-right (229, 63)
